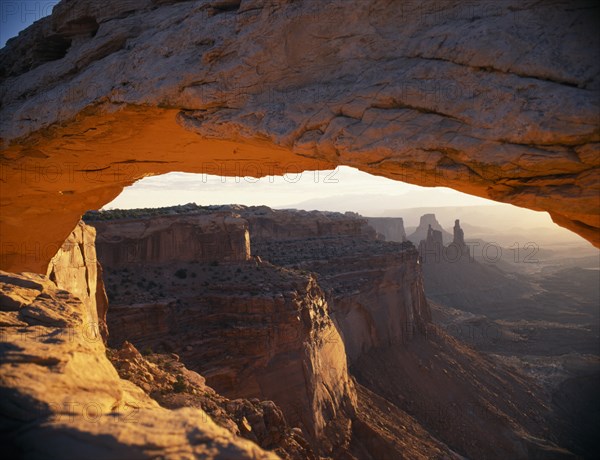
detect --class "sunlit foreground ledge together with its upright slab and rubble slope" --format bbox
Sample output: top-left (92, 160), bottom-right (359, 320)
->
top-left (0, 219), bottom-right (324, 460)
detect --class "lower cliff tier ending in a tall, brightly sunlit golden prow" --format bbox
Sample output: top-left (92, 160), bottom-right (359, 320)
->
top-left (102, 261), bottom-right (355, 452)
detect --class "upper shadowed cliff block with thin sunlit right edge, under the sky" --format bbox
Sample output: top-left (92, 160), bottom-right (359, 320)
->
top-left (94, 213), bottom-right (250, 268)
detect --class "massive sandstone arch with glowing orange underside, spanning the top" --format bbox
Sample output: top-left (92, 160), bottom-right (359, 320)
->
top-left (0, 0), bottom-right (600, 272)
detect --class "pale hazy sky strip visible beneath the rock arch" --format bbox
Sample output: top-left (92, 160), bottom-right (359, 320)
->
top-left (103, 166), bottom-right (587, 245)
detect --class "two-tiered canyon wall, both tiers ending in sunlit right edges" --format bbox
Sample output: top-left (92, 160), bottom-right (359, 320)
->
top-left (88, 208), bottom-right (358, 454)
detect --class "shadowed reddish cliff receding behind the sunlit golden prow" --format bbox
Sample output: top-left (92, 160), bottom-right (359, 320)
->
top-left (230, 207), bottom-right (430, 361)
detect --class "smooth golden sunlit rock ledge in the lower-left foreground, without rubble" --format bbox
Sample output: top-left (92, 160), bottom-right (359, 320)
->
top-left (0, 272), bottom-right (278, 460)
